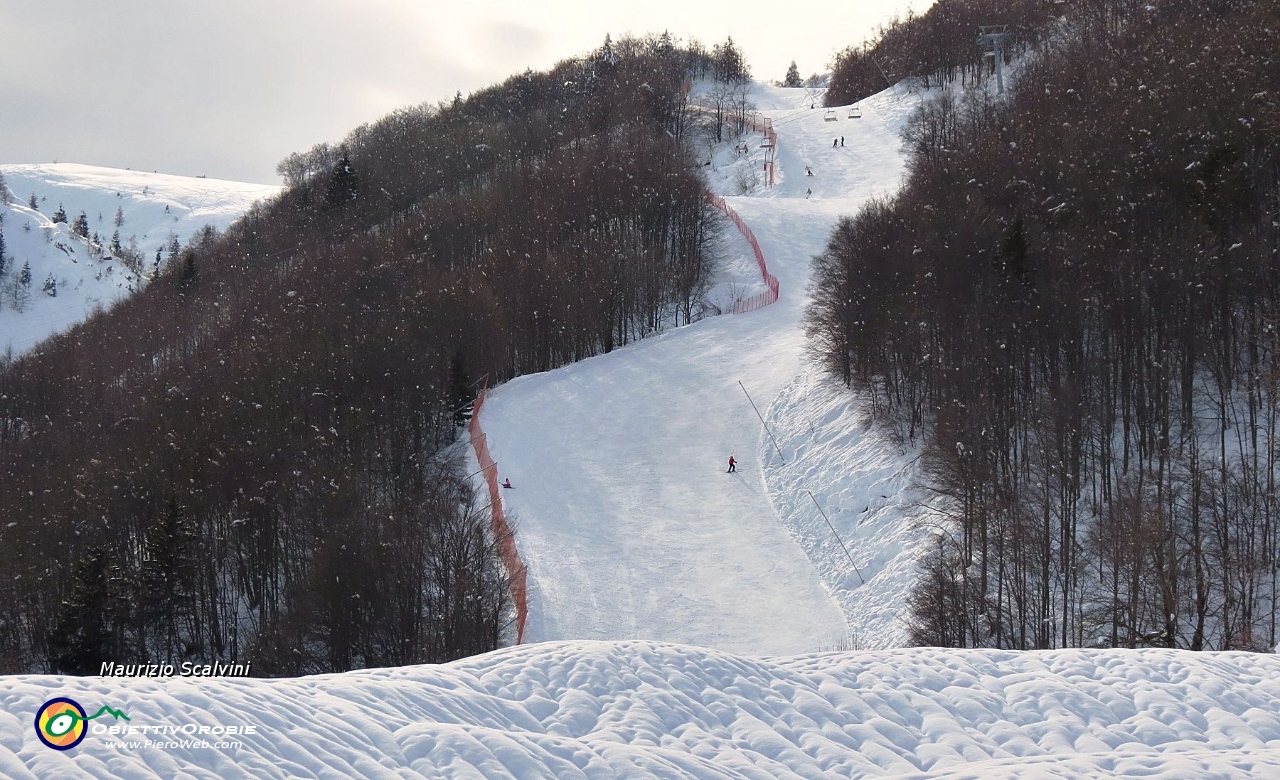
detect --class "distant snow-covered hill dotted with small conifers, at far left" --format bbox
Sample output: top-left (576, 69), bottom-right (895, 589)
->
top-left (0, 163), bottom-right (279, 355)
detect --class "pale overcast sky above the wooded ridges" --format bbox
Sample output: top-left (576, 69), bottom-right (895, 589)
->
top-left (0, 0), bottom-right (932, 183)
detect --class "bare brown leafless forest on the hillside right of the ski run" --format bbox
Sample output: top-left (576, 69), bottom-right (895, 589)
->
top-left (809, 0), bottom-right (1280, 651)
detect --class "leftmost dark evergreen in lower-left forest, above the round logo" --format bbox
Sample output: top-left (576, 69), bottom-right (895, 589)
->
top-left (49, 547), bottom-right (114, 675)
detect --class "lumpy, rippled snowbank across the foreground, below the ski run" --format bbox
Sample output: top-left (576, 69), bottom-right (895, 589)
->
top-left (0, 642), bottom-right (1280, 780)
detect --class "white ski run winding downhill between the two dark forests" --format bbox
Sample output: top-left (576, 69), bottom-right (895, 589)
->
top-left (481, 86), bottom-right (931, 654)
